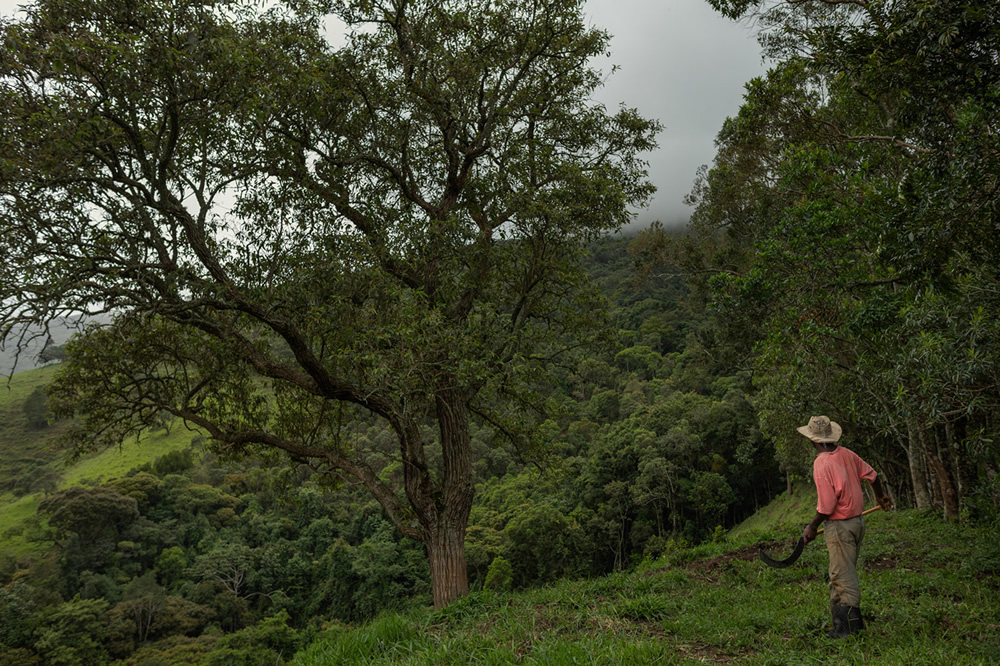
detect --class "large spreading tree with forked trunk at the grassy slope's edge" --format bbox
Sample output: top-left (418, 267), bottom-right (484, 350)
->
top-left (0, 0), bottom-right (658, 606)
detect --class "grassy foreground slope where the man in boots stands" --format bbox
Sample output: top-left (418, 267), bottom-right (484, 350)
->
top-left (294, 493), bottom-right (1000, 666)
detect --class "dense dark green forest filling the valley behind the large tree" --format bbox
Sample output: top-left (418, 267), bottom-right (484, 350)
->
top-left (0, 238), bottom-right (785, 664)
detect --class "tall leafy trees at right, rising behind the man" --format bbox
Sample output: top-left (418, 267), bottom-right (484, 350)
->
top-left (640, 0), bottom-right (1000, 517)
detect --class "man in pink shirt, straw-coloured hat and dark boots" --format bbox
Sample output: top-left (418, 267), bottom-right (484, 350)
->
top-left (797, 416), bottom-right (892, 638)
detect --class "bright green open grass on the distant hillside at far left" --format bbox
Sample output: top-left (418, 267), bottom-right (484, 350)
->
top-left (0, 366), bottom-right (195, 556)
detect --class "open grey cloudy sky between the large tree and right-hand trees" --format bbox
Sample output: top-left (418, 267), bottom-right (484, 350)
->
top-left (0, 0), bottom-right (765, 227)
